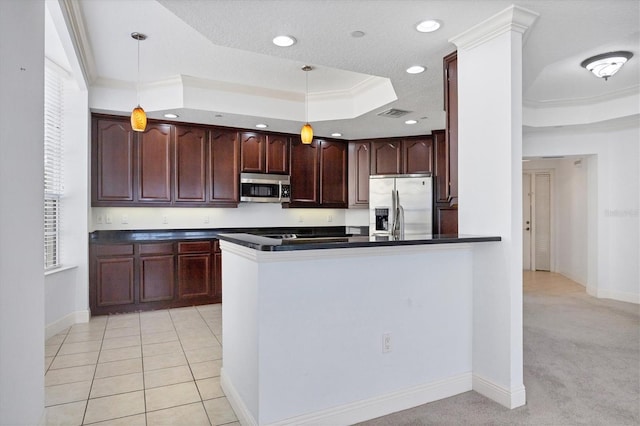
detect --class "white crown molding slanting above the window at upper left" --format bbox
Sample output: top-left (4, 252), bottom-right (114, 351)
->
top-left (58, 0), bottom-right (96, 85)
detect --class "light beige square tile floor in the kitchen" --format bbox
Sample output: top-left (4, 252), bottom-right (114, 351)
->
top-left (45, 304), bottom-right (239, 426)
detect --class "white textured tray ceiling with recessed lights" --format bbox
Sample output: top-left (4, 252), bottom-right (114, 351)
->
top-left (51, 0), bottom-right (640, 139)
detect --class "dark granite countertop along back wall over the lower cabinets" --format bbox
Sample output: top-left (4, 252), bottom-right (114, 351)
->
top-left (89, 226), bottom-right (369, 244)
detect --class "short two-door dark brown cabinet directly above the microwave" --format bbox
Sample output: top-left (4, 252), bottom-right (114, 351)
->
top-left (240, 132), bottom-right (290, 174)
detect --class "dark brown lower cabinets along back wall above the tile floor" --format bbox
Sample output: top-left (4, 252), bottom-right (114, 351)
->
top-left (89, 240), bottom-right (222, 315)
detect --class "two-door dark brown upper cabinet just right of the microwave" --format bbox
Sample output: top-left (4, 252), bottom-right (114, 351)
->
top-left (289, 139), bottom-right (348, 208)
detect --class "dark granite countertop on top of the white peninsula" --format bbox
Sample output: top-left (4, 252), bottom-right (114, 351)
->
top-left (218, 233), bottom-right (502, 251)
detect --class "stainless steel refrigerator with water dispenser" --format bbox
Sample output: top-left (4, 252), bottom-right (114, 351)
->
top-left (369, 174), bottom-right (433, 239)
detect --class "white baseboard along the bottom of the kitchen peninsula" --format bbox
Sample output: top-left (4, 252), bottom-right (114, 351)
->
top-left (220, 368), bottom-right (472, 426)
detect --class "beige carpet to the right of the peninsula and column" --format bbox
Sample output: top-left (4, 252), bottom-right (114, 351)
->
top-left (362, 272), bottom-right (640, 426)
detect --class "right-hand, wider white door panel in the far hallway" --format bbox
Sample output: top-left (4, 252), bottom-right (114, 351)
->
top-left (533, 173), bottom-right (551, 271)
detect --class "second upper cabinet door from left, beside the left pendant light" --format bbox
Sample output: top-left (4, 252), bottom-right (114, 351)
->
top-left (137, 124), bottom-right (172, 203)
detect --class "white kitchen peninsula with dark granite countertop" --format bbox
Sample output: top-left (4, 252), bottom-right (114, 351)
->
top-left (218, 234), bottom-right (501, 425)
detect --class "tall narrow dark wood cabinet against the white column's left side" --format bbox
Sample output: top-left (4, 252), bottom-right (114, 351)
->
top-left (444, 52), bottom-right (458, 205)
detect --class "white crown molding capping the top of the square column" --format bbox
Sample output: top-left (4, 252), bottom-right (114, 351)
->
top-left (449, 5), bottom-right (540, 50)
